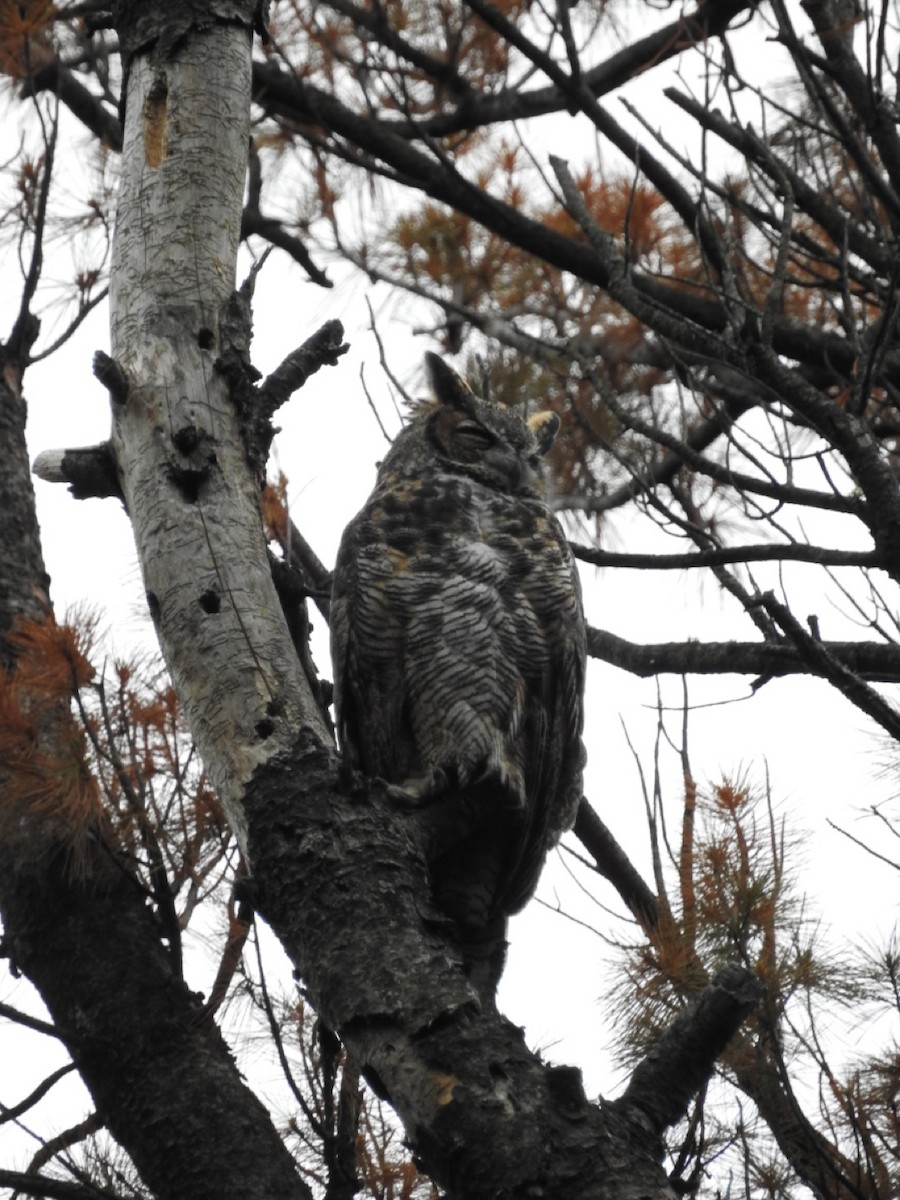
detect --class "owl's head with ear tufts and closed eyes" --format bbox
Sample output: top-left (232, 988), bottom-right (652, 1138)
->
top-left (386, 354), bottom-right (559, 498)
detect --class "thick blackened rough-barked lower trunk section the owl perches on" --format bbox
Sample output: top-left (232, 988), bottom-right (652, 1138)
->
top-left (247, 734), bottom-right (671, 1200)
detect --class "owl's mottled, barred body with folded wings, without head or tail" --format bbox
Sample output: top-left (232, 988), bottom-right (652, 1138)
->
top-left (332, 472), bottom-right (586, 912)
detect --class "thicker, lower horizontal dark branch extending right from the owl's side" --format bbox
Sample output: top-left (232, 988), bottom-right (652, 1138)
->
top-left (588, 629), bottom-right (900, 683)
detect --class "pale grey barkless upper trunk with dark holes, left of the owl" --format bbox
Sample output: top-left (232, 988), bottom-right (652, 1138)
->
top-left (109, 0), bottom-right (324, 859)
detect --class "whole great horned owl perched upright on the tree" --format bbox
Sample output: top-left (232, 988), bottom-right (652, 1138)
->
top-left (331, 354), bottom-right (586, 997)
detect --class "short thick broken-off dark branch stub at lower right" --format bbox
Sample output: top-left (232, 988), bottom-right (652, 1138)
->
top-left (616, 965), bottom-right (763, 1134)
